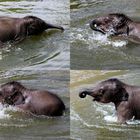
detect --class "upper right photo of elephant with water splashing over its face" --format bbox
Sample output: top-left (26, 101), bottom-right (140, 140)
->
top-left (70, 0), bottom-right (140, 70)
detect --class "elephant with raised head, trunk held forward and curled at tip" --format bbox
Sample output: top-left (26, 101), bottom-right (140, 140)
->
top-left (79, 78), bottom-right (140, 123)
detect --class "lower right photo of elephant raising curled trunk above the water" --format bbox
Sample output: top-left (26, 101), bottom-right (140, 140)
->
top-left (70, 70), bottom-right (140, 140)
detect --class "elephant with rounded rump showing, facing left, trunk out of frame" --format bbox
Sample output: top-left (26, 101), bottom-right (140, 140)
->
top-left (0, 81), bottom-right (65, 116)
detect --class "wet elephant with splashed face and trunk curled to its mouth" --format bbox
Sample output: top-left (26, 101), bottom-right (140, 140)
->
top-left (90, 13), bottom-right (140, 38)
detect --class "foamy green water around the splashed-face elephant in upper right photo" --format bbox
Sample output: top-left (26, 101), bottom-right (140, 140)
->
top-left (70, 0), bottom-right (140, 70)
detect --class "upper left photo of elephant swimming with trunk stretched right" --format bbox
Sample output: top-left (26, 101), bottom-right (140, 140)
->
top-left (0, 0), bottom-right (70, 70)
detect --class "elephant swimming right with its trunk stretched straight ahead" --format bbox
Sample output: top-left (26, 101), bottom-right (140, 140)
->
top-left (0, 16), bottom-right (64, 44)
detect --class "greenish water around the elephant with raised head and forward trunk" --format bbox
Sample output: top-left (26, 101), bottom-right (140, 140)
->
top-left (70, 70), bottom-right (140, 140)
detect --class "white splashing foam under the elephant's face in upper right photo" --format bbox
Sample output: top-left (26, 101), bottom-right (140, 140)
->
top-left (70, 28), bottom-right (128, 49)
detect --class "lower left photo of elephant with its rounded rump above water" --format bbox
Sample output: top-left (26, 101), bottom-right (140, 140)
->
top-left (0, 70), bottom-right (70, 140)
